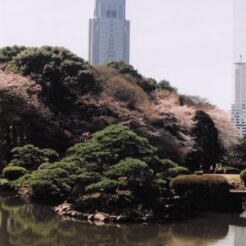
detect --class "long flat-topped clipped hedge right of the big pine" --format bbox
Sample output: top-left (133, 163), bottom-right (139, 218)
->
top-left (170, 175), bottom-right (229, 197)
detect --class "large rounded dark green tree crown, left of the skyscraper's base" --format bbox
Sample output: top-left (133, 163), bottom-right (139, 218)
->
top-left (5, 46), bottom-right (100, 110)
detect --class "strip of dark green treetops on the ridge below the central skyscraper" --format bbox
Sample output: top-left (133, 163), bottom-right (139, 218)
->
top-left (107, 61), bottom-right (157, 92)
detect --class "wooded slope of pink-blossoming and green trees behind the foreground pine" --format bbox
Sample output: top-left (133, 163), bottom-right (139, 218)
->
top-left (0, 46), bottom-right (238, 168)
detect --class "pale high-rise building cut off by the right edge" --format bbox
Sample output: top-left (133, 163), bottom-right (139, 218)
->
top-left (231, 61), bottom-right (246, 137)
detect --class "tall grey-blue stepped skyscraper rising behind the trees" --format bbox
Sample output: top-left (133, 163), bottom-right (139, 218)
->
top-left (89, 0), bottom-right (130, 65)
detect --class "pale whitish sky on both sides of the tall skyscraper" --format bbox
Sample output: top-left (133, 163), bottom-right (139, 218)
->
top-left (0, 0), bottom-right (237, 110)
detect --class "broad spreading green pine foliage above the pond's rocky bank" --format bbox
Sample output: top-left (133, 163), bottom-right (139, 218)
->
top-left (17, 125), bottom-right (166, 203)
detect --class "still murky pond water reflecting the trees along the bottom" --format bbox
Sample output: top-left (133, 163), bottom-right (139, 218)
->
top-left (0, 195), bottom-right (246, 246)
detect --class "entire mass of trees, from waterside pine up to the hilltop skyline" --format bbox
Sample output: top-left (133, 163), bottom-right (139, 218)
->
top-left (0, 46), bottom-right (243, 221)
